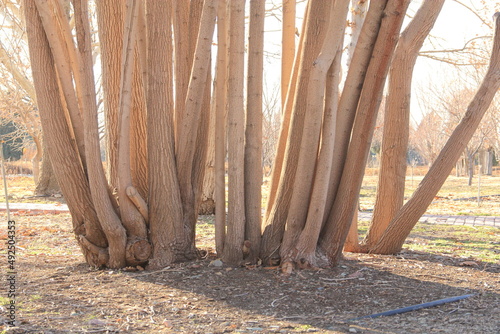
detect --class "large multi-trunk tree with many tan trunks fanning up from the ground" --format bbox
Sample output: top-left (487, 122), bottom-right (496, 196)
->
top-left (24, 0), bottom-right (500, 272)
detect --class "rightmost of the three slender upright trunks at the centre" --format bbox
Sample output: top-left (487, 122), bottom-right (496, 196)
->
top-left (245, 0), bottom-right (265, 262)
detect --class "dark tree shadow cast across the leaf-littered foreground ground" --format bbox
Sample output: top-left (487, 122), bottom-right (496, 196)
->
top-left (124, 252), bottom-right (500, 333)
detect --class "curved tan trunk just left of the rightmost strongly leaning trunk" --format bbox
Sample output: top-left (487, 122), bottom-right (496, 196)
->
top-left (364, 0), bottom-right (444, 247)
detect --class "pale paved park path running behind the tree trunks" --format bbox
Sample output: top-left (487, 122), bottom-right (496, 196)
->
top-left (0, 203), bottom-right (500, 227)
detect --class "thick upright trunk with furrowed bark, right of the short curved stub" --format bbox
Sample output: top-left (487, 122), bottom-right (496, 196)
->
top-left (146, 0), bottom-right (189, 268)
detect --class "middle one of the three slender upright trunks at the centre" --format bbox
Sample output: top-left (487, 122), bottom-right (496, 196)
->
top-left (222, 0), bottom-right (246, 265)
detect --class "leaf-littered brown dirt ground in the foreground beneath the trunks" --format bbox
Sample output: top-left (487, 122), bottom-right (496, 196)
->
top-left (0, 214), bottom-right (500, 334)
